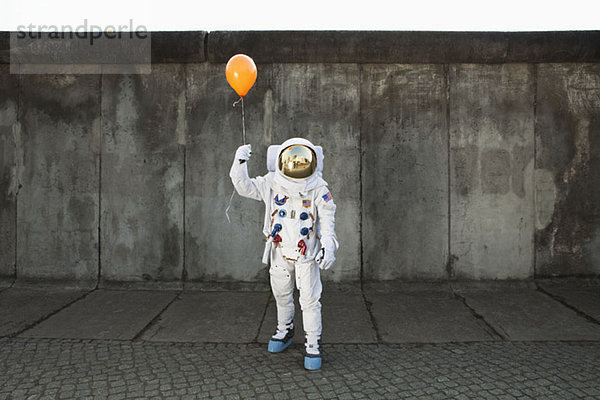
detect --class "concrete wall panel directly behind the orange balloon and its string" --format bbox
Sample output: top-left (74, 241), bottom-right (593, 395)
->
top-left (185, 64), bottom-right (273, 282)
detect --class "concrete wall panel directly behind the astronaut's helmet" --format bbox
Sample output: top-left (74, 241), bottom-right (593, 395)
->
top-left (265, 64), bottom-right (361, 282)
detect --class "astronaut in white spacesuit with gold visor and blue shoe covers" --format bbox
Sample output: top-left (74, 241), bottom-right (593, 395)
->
top-left (229, 138), bottom-right (339, 370)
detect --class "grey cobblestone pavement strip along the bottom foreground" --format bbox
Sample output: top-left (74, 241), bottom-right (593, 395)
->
top-left (0, 338), bottom-right (600, 399)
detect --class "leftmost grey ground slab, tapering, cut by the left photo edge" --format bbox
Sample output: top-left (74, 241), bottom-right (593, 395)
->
top-left (0, 288), bottom-right (87, 336)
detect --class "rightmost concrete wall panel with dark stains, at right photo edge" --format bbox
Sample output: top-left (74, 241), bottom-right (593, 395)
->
top-left (536, 64), bottom-right (600, 277)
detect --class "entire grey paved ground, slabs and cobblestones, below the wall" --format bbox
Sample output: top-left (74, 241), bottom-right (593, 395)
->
top-left (0, 279), bottom-right (600, 399)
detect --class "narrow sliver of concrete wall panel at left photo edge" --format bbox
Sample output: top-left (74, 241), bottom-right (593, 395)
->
top-left (0, 65), bottom-right (19, 278)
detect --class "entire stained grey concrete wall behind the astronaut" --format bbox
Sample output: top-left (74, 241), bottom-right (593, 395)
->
top-left (0, 32), bottom-right (600, 286)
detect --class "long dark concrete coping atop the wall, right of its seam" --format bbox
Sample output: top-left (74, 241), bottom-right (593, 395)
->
top-left (205, 31), bottom-right (600, 64)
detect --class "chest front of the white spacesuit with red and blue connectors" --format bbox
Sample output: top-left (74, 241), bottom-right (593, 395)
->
top-left (270, 190), bottom-right (317, 260)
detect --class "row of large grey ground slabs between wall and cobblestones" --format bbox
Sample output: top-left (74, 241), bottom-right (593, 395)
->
top-left (0, 280), bottom-right (600, 345)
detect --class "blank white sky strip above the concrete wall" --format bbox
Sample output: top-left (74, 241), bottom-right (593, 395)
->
top-left (0, 0), bottom-right (600, 31)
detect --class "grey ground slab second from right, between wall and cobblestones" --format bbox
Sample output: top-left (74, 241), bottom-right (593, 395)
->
top-left (457, 288), bottom-right (600, 340)
